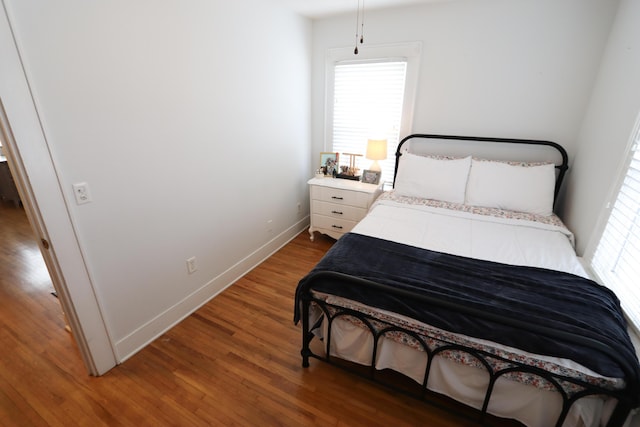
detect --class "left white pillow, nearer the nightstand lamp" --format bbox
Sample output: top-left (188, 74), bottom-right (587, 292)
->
top-left (394, 153), bottom-right (471, 203)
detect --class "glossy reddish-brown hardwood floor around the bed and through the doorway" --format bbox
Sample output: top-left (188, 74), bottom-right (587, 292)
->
top-left (0, 204), bottom-right (520, 427)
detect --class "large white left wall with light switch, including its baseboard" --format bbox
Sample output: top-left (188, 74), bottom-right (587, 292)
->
top-left (5, 0), bottom-right (311, 361)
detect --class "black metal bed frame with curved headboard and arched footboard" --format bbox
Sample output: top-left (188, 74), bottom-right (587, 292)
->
top-left (299, 134), bottom-right (640, 427)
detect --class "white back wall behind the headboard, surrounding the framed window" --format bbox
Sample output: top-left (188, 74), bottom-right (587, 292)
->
top-left (312, 0), bottom-right (618, 181)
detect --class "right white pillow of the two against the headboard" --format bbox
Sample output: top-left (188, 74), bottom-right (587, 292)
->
top-left (466, 159), bottom-right (556, 216)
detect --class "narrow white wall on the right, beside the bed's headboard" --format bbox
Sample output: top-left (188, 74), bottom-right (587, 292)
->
top-left (564, 0), bottom-right (640, 254)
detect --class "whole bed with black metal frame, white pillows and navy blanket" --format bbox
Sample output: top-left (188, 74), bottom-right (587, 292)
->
top-left (294, 134), bottom-right (640, 427)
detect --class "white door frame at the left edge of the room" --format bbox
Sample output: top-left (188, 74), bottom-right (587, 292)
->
top-left (0, 0), bottom-right (117, 376)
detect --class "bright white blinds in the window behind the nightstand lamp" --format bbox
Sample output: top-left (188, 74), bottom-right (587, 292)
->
top-left (332, 59), bottom-right (407, 182)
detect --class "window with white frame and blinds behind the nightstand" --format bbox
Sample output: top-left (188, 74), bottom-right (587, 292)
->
top-left (325, 43), bottom-right (421, 186)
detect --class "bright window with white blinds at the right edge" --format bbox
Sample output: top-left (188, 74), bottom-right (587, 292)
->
top-left (591, 119), bottom-right (640, 328)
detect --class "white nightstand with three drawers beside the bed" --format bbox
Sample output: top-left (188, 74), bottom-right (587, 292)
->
top-left (307, 178), bottom-right (382, 240)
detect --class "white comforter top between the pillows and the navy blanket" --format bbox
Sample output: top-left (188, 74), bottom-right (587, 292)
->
top-left (352, 195), bottom-right (588, 277)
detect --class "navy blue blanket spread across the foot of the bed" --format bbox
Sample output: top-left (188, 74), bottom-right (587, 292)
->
top-left (294, 233), bottom-right (640, 382)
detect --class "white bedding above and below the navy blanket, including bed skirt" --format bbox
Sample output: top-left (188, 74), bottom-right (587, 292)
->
top-left (316, 191), bottom-right (622, 427)
